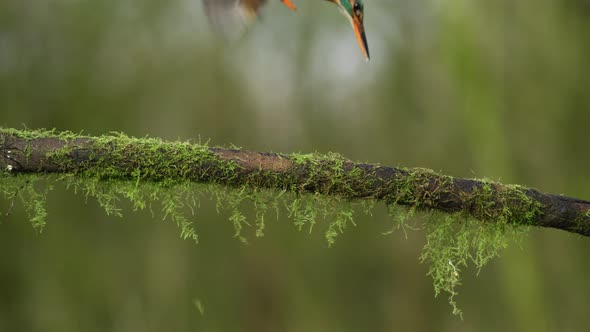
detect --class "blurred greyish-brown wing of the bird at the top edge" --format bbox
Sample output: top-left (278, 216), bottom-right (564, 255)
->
top-left (203, 0), bottom-right (266, 39)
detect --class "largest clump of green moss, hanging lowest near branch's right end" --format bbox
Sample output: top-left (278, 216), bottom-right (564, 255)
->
top-left (420, 180), bottom-right (542, 315)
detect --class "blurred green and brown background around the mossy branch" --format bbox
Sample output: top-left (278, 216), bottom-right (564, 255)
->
top-left (0, 0), bottom-right (590, 332)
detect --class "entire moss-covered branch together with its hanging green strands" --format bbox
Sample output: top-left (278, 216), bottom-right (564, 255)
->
top-left (0, 128), bottom-right (590, 315)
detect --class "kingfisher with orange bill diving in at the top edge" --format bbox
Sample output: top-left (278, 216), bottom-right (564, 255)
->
top-left (203, 0), bottom-right (369, 60)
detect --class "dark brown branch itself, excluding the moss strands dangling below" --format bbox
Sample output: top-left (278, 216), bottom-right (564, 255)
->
top-left (0, 129), bottom-right (590, 236)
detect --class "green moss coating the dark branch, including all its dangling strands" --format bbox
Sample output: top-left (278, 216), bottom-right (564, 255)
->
top-left (0, 129), bottom-right (552, 314)
